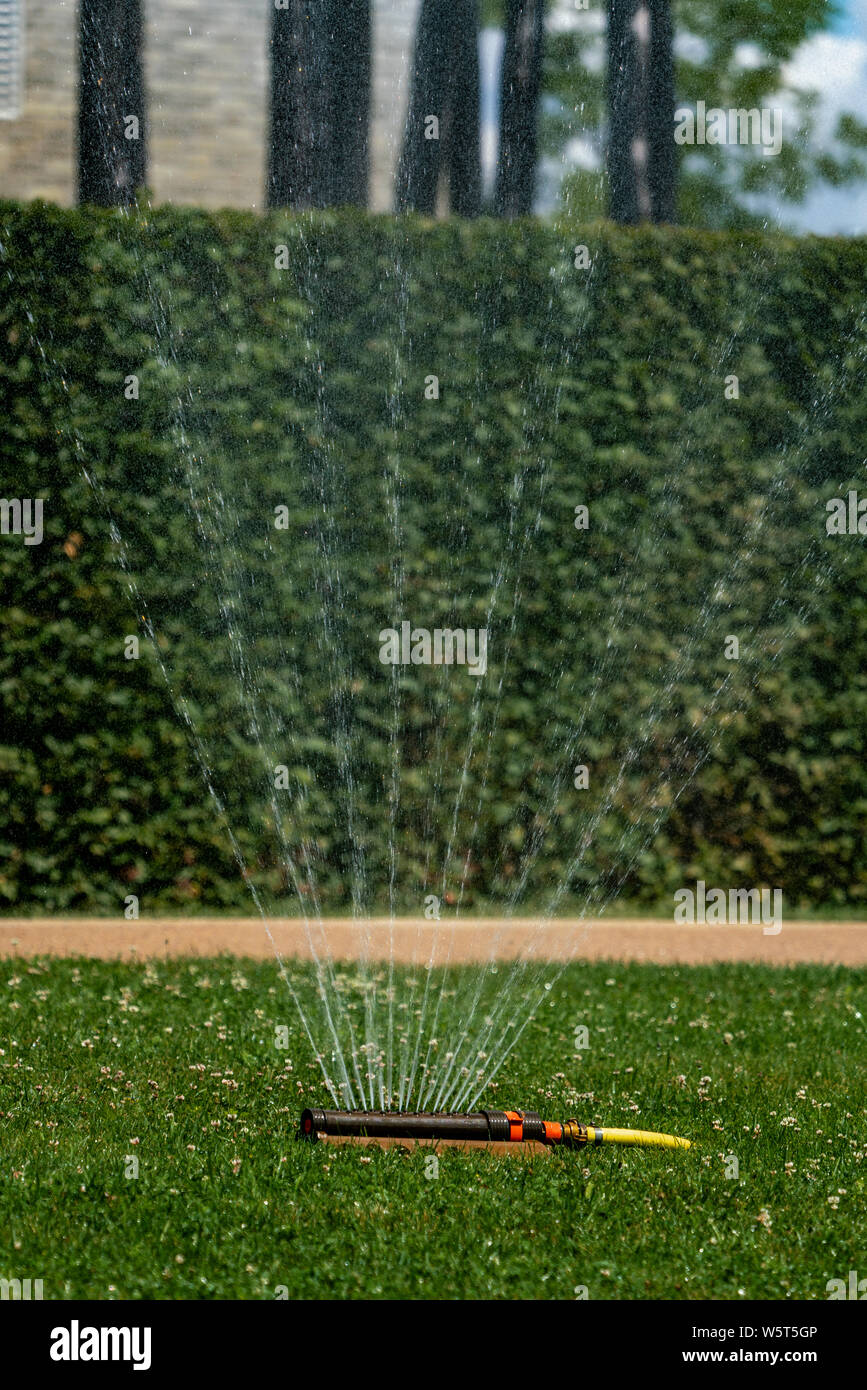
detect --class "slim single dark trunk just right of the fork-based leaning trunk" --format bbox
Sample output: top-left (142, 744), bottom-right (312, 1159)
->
top-left (493, 0), bottom-right (545, 217)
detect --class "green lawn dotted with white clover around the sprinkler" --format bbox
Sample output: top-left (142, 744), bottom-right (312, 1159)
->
top-left (0, 959), bottom-right (867, 1300)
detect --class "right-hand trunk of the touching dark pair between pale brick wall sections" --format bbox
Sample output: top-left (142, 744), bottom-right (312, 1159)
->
top-left (328, 0), bottom-right (371, 207)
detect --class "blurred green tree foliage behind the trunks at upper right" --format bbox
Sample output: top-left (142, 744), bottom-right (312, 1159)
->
top-left (479, 0), bottom-right (867, 229)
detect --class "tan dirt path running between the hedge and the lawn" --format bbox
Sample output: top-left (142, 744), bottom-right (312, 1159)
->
top-left (0, 917), bottom-right (867, 966)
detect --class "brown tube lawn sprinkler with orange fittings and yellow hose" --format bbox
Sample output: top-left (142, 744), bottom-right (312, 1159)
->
top-left (299, 1109), bottom-right (691, 1148)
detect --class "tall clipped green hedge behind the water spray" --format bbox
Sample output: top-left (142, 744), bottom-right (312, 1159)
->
top-left (0, 203), bottom-right (867, 912)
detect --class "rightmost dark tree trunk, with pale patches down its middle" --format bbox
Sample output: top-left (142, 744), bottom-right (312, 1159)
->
top-left (609, 0), bottom-right (677, 222)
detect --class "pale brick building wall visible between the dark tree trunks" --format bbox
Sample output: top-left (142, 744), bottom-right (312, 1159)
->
top-left (0, 0), bottom-right (420, 211)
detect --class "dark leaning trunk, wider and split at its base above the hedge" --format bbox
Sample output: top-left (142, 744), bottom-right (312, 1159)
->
top-left (396, 0), bottom-right (482, 217)
